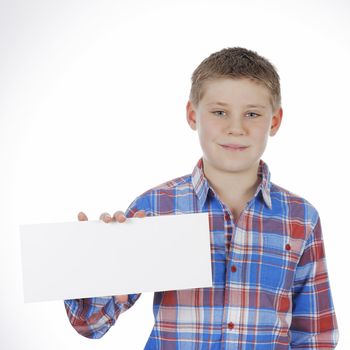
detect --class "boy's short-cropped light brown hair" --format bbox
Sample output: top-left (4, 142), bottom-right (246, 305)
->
top-left (189, 47), bottom-right (281, 110)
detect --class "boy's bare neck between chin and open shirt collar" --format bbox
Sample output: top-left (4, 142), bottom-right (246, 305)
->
top-left (203, 158), bottom-right (260, 201)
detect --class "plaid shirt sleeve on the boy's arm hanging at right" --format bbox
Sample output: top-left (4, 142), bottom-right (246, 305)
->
top-left (290, 216), bottom-right (338, 350)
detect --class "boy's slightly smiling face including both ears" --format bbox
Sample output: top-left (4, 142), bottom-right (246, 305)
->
top-left (186, 78), bottom-right (282, 173)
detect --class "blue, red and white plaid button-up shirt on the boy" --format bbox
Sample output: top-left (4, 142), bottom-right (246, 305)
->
top-left (65, 158), bottom-right (338, 350)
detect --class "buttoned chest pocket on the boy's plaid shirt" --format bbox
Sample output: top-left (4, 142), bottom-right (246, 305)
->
top-left (257, 234), bottom-right (296, 291)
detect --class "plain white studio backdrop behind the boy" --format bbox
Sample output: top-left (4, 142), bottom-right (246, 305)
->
top-left (0, 0), bottom-right (350, 350)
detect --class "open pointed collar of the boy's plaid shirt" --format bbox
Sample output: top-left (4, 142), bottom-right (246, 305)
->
top-left (191, 158), bottom-right (272, 209)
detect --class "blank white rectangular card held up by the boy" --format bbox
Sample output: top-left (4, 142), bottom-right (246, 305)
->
top-left (20, 213), bottom-right (212, 302)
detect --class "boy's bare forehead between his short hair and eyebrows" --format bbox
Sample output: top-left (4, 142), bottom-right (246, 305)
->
top-left (201, 78), bottom-right (271, 105)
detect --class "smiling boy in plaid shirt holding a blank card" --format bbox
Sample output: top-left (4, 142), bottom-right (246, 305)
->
top-left (65, 47), bottom-right (338, 350)
